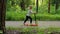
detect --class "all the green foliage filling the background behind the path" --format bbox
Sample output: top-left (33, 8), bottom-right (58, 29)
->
top-left (6, 0), bottom-right (60, 20)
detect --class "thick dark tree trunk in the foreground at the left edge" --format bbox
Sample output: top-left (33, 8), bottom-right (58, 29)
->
top-left (0, 0), bottom-right (6, 34)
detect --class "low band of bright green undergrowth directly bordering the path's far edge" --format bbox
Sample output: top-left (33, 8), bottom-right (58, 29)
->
top-left (6, 11), bottom-right (60, 21)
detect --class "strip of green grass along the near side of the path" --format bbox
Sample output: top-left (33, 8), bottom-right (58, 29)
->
top-left (6, 27), bottom-right (60, 34)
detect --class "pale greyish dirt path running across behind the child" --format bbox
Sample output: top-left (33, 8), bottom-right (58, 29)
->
top-left (5, 21), bottom-right (60, 27)
